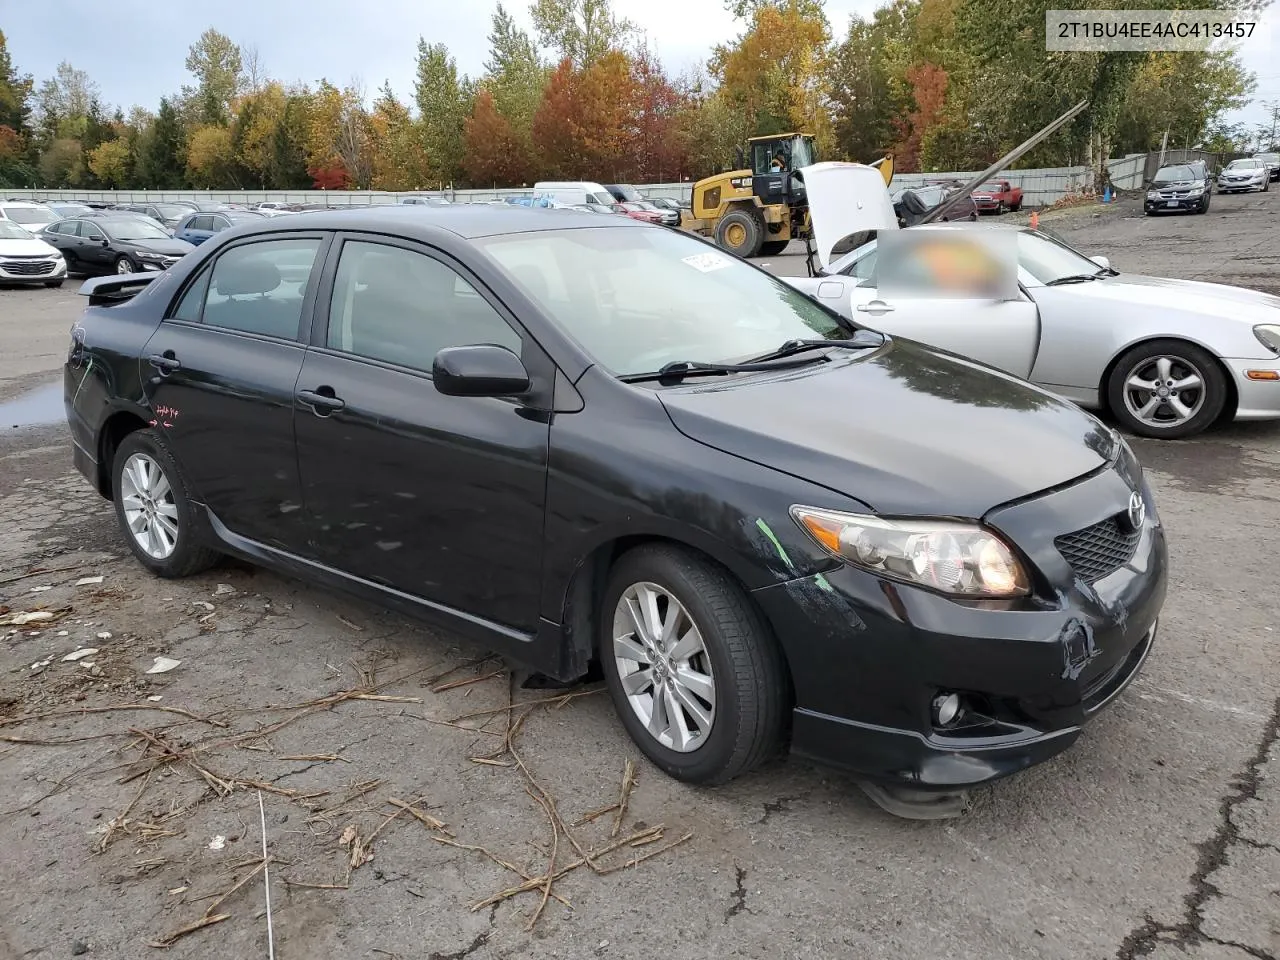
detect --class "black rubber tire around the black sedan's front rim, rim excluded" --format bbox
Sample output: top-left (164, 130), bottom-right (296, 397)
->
top-left (596, 545), bottom-right (790, 785)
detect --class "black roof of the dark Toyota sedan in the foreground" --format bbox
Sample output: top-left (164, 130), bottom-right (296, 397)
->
top-left (242, 204), bottom-right (645, 239)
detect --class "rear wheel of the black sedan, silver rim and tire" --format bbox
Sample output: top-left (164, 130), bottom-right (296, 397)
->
top-left (111, 430), bottom-right (218, 577)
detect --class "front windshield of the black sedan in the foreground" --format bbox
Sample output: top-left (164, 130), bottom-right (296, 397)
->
top-left (476, 228), bottom-right (855, 376)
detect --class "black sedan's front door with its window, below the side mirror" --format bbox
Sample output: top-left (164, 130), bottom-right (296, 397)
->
top-left (296, 237), bottom-right (550, 634)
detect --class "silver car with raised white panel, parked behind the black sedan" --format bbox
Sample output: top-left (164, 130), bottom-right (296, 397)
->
top-left (783, 163), bottom-right (1280, 439)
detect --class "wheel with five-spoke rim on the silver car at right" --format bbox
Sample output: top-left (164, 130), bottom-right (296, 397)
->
top-left (1107, 340), bottom-right (1228, 440)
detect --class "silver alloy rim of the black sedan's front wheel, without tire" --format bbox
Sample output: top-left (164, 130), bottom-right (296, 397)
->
top-left (613, 582), bottom-right (716, 753)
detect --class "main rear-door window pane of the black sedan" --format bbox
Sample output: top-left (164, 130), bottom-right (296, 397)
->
top-left (204, 239), bottom-right (320, 340)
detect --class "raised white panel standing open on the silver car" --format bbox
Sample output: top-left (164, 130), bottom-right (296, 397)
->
top-left (796, 163), bottom-right (897, 268)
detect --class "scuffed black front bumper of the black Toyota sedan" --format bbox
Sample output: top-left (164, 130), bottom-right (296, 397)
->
top-left (755, 455), bottom-right (1167, 791)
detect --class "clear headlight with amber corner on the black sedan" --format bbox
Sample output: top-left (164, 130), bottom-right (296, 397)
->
top-left (791, 506), bottom-right (1030, 598)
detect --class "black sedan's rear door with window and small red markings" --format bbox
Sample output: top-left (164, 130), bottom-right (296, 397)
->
top-left (140, 234), bottom-right (325, 552)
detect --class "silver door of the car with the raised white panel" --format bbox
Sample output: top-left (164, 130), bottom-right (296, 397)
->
top-left (815, 248), bottom-right (1039, 379)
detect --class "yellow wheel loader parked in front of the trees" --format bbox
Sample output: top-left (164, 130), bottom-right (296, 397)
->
top-left (680, 133), bottom-right (893, 257)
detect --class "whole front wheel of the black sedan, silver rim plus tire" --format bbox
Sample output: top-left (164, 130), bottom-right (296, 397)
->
top-left (599, 547), bottom-right (790, 783)
